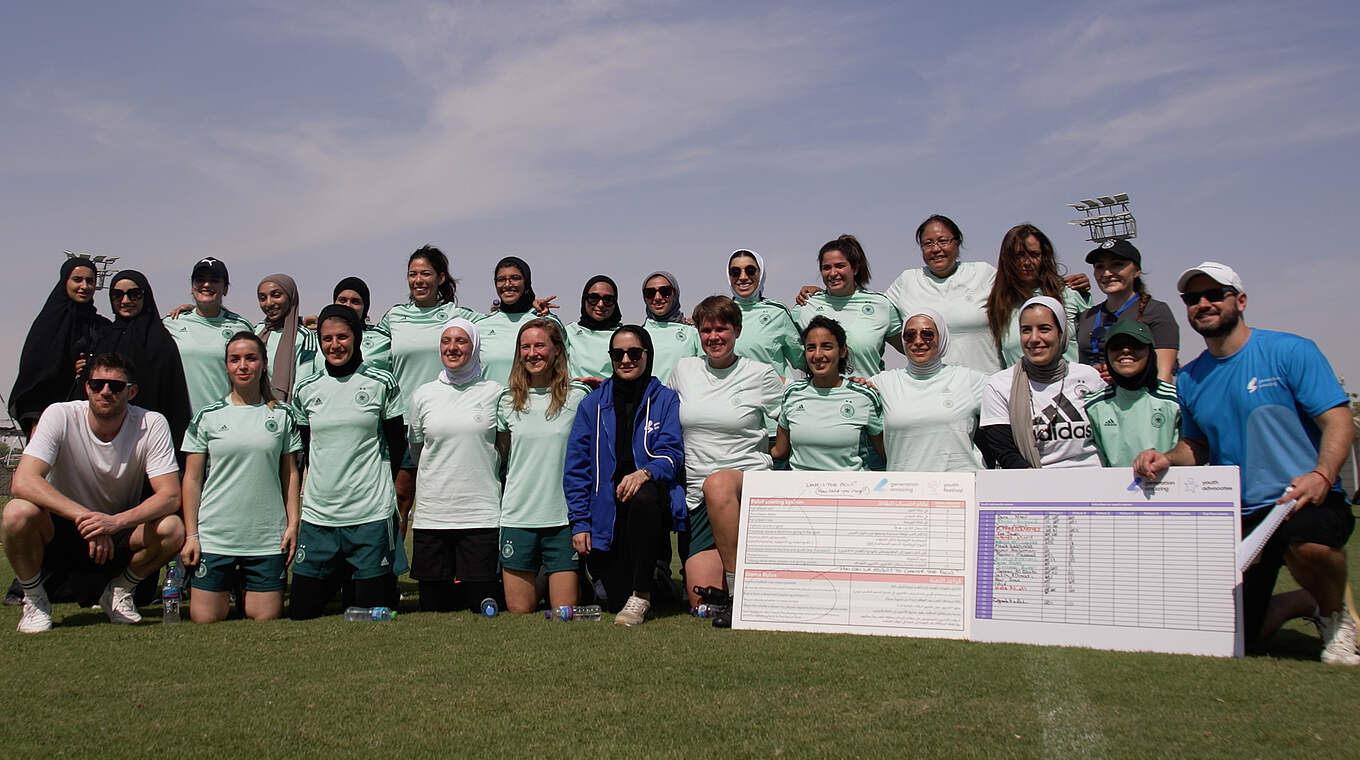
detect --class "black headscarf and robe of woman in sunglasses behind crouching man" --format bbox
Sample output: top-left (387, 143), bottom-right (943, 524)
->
top-left (94, 269), bottom-right (193, 446)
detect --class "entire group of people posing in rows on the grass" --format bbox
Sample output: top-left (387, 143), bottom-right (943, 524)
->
top-left (0, 213), bottom-right (1360, 665)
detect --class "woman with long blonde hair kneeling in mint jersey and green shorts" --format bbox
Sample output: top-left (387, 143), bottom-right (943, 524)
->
top-left (496, 318), bottom-right (590, 615)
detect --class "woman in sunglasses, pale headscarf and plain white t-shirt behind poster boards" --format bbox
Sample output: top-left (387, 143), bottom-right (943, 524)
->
top-left (870, 309), bottom-right (990, 472)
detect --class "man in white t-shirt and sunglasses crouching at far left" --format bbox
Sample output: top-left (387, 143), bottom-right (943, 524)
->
top-left (0, 353), bottom-right (184, 634)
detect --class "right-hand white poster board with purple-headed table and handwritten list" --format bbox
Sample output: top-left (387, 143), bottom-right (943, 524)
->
top-left (971, 466), bottom-right (1243, 657)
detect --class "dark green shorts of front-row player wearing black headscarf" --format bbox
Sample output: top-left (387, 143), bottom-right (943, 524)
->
top-left (292, 518), bottom-right (405, 581)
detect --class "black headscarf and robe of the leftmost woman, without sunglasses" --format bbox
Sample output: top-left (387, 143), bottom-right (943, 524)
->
top-left (10, 257), bottom-right (109, 430)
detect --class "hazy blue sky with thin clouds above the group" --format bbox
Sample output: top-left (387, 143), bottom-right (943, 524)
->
top-left (0, 0), bottom-right (1360, 407)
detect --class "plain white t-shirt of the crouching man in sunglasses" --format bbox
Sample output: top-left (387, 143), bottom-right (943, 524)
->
top-left (23, 401), bottom-right (180, 514)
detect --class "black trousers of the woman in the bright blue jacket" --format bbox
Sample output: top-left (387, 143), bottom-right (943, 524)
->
top-left (586, 480), bottom-right (670, 612)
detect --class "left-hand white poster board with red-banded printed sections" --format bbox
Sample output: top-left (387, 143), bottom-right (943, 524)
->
top-left (732, 472), bottom-right (976, 639)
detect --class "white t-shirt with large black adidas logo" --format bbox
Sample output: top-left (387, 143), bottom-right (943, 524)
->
top-left (981, 362), bottom-right (1104, 468)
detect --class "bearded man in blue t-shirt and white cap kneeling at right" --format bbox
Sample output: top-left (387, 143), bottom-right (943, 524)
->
top-left (1133, 261), bottom-right (1360, 665)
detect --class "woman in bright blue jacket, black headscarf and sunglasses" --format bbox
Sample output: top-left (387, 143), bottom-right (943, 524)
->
top-left (562, 325), bottom-right (687, 625)
